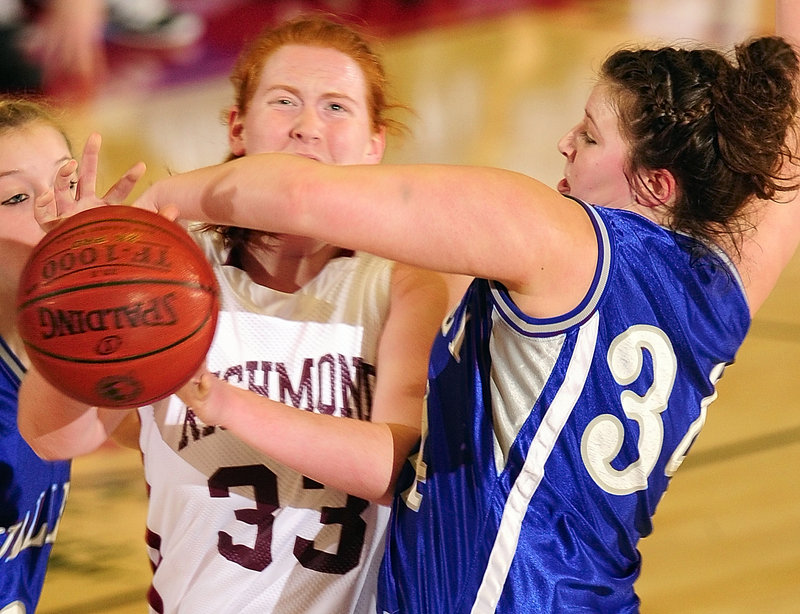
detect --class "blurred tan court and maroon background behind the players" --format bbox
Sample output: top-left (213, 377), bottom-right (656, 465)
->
top-left (0, 0), bottom-right (800, 614)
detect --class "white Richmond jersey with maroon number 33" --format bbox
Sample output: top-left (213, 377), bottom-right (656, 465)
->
top-left (140, 233), bottom-right (392, 614)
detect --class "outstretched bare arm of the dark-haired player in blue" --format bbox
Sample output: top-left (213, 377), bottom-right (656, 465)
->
top-left (135, 154), bottom-right (597, 317)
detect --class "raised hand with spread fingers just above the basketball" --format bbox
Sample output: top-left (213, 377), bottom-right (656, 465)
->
top-left (33, 133), bottom-right (146, 232)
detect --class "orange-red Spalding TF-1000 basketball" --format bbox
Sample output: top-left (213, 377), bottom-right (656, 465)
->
top-left (17, 205), bottom-right (219, 408)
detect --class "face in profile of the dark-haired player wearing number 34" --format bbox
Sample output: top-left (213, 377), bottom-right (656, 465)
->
top-left (558, 85), bottom-right (634, 209)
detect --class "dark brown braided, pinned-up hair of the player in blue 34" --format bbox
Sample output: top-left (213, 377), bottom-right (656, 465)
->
top-left (600, 36), bottom-right (798, 249)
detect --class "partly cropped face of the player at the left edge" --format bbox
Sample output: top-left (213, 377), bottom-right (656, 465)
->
top-left (0, 123), bottom-right (72, 245)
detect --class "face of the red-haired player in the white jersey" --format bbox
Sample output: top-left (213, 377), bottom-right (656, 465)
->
top-left (229, 45), bottom-right (385, 164)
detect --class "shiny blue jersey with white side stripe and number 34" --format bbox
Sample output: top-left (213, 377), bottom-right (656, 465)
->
top-left (378, 206), bottom-right (750, 614)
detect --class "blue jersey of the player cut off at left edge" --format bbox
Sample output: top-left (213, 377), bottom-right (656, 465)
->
top-left (0, 337), bottom-right (70, 614)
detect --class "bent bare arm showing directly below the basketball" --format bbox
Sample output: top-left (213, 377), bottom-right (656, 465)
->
top-left (17, 367), bottom-right (127, 460)
